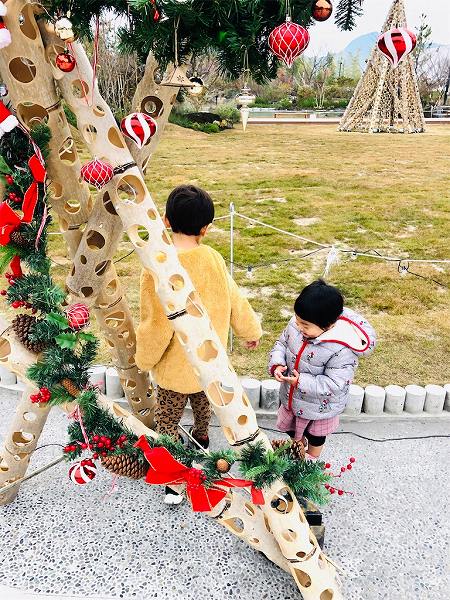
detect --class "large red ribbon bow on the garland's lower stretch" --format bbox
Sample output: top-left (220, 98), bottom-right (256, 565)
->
top-left (135, 436), bottom-right (264, 512)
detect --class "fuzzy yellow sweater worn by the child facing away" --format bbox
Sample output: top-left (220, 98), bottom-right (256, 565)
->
top-left (136, 246), bottom-right (262, 394)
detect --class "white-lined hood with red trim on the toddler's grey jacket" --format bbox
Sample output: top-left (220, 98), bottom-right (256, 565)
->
top-left (314, 309), bottom-right (373, 354)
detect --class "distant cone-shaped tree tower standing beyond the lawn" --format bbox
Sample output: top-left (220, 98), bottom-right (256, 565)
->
top-left (339, 0), bottom-right (425, 133)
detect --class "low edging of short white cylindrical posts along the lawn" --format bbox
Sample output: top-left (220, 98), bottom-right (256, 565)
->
top-left (0, 365), bottom-right (450, 421)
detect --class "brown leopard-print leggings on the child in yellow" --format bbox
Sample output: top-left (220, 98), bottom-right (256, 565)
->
top-left (155, 386), bottom-right (211, 438)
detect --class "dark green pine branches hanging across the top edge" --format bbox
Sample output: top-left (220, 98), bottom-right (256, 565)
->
top-left (43, 0), bottom-right (362, 82)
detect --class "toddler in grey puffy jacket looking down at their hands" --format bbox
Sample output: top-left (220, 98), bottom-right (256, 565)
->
top-left (269, 280), bottom-right (376, 459)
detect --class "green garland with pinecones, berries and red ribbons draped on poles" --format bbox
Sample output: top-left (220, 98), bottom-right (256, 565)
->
top-left (0, 116), bottom-right (331, 510)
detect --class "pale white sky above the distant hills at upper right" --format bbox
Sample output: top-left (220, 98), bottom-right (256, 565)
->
top-left (306, 0), bottom-right (450, 54)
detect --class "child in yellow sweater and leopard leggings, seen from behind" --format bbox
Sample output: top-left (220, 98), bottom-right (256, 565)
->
top-left (136, 185), bottom-right (262, 504)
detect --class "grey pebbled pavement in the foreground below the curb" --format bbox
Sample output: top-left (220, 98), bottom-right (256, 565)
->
top-left (0, 396), bottom-right (450, 600)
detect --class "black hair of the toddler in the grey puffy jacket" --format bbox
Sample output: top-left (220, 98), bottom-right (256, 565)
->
top-left (294, 279), bottom-right (344, 329)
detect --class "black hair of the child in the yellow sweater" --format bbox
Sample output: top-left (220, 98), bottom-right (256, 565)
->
top-left (166, 185), bottom-right (214, 235)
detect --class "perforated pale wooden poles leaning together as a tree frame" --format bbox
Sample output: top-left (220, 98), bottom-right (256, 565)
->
top-left (0, 0), bottom-right (372, 600)
